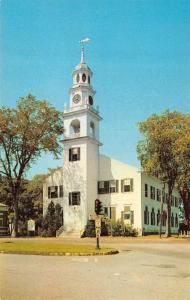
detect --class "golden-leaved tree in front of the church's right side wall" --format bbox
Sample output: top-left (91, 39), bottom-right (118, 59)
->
top-left (137, 111), bottom-right (190, 236)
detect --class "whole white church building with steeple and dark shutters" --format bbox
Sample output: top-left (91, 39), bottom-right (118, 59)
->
top-left (43, 47), bottom-right (179, 236)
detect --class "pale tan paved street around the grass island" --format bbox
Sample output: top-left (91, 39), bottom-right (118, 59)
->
top-left (0, 240), bottom-right (190, 300)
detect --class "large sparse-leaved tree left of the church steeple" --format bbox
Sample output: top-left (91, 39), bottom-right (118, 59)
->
top-left (0, 94), bottom-right (63, 236)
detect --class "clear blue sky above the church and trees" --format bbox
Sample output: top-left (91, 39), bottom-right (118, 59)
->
top-left (0, 0), bottom-right (190, 176)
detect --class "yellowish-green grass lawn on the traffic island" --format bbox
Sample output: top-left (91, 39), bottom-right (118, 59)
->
top-left (0, 240), bottom-right (118, 255)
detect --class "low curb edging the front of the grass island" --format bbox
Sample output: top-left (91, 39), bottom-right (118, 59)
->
top-left (0, 250), bottom-right (119, 256)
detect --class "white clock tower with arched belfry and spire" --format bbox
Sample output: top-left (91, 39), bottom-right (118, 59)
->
top-left (63, 47), bottom-right (101, 234)
